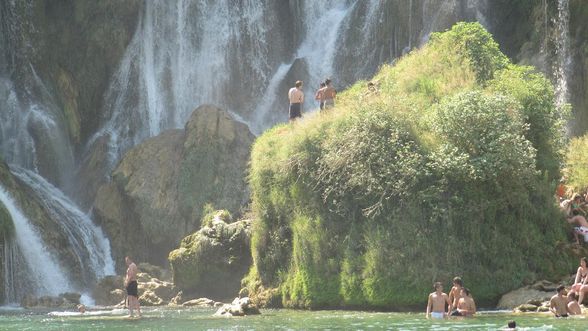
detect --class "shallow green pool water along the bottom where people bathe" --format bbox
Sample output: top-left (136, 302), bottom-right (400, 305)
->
top-left (0, 308), bottom-right (588, 331)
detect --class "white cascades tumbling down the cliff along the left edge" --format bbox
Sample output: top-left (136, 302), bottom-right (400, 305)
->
top-left (0, 1), bottom-right (114, 302)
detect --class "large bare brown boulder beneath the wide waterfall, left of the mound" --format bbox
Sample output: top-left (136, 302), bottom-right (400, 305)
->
top-left (94, 106), bottom-right (254, 266)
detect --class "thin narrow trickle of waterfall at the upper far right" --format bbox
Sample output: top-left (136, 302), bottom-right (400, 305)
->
top-left (553, 0), bottom-right (571, 106)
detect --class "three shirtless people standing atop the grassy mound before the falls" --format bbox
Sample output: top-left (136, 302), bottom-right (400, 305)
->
top-left (288, 78), bottom-right (337, 121)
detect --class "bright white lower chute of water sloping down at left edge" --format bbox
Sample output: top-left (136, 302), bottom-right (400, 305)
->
top-left (0, 186), bottom-right (72, 299)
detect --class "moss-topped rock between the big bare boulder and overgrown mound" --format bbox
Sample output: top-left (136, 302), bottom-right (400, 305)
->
top-left (169, 211), bottom-right (251, 299)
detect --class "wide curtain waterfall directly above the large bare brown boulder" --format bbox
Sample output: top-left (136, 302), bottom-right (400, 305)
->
top-left (96, 0), bottom-right (270, 162)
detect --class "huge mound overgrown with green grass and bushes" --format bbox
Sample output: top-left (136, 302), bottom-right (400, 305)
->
top-left (246, 23), bottom-right (575, 309)
